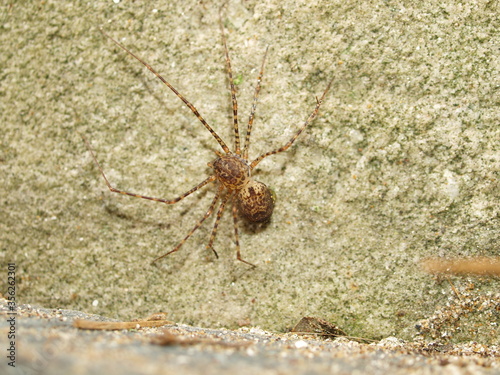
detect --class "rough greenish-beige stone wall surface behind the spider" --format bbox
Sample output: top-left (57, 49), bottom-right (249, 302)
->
top-left (0, 0), bottom-right (500, 344)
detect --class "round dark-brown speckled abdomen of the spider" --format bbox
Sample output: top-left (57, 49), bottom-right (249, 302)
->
top-left (237, 180), bottom-right (275, 223)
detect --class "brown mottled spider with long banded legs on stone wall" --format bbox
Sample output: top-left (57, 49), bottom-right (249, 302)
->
top-left (82, 13), bottom-right (332, 267)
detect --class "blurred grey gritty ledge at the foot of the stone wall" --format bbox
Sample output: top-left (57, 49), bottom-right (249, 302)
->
top-left (0, 300), bottom-right (500, 375)
